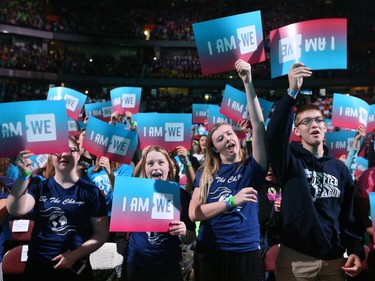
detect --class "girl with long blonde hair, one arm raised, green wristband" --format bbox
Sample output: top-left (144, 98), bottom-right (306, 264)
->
top-left (189, 60), bottom-right (268, 281)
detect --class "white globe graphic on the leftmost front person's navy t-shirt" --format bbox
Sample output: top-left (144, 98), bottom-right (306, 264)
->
top-left (40, 207), bottom-right (76, 235)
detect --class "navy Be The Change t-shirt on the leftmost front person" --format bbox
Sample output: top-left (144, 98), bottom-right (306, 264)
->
top-left (28, 178), bottom-right (107, 262)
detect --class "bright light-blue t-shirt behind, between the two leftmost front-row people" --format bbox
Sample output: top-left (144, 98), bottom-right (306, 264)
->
top-left (87, 164), bottom-right (133, 217)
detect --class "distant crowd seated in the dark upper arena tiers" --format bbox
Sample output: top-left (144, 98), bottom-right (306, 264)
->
top-left (0, 0), bottom-right (375, 88)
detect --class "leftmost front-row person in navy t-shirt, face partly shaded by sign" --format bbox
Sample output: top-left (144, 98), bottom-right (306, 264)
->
top-left (7, 138), bottom-right (109, 281)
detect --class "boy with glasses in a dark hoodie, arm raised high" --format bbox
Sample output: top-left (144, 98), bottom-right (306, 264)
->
top-left (266, 63), bottom-right (364, 281)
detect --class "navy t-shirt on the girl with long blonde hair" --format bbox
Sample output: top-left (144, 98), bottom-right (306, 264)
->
top-left (194, 157), bottom-right (267, 252)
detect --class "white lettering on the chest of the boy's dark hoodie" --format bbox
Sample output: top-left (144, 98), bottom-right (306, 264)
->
top-left (305, 169), bottom-right (341, 201)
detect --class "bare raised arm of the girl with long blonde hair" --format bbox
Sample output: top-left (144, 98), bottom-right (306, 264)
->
top-left (236, 60), bottom-right (268, 169)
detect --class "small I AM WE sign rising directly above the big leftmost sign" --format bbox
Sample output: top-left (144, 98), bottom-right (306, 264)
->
top-left (47, 87), bottom-right (87, 120)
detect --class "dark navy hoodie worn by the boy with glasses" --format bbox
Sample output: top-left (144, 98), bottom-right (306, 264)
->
top-left (266, 95), bottom-right (364, 260)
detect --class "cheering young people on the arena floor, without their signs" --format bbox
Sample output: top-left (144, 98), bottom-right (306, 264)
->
top-left (0, 60), bottom-right (375, 281)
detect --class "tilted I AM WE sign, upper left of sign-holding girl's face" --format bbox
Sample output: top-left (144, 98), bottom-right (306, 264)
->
top-left (82, 116), bottom-right (138, 164)
